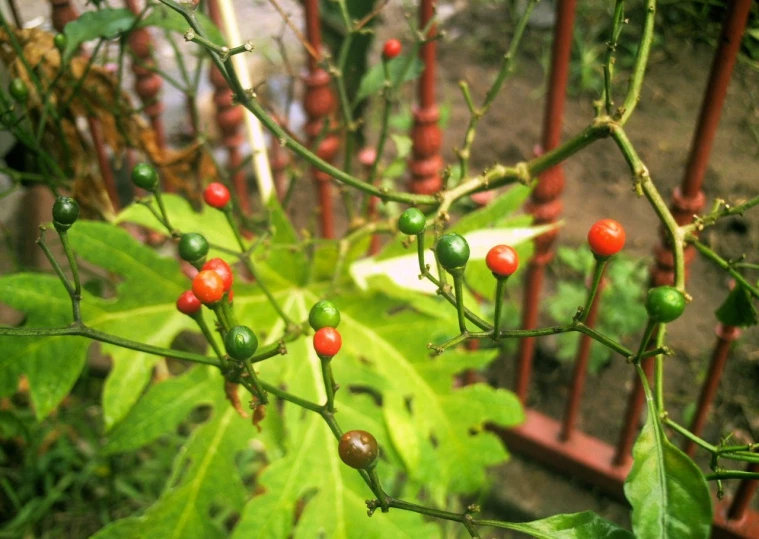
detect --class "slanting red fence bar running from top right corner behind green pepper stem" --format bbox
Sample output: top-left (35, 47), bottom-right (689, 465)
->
top-left (614, 0), bottom-right (751, 464)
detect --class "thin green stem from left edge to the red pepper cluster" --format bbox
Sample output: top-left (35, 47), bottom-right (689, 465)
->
top-left (0, 324), bottom-right (221, 367)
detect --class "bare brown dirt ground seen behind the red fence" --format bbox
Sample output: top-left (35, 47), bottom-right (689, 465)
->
top-left (1, 2), bottom-right (759, 526)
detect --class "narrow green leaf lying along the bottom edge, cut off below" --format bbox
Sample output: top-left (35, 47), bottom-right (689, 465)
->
top-left (504, 511), bottom-right (636, 539)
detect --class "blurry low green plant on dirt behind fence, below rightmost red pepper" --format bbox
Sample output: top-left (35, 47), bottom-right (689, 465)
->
top-left (546, 245), bottom-right (648, 374)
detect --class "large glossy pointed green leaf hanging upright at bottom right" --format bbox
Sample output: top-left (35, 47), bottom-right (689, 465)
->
top-left (625, 380), bottom-right (712, 539)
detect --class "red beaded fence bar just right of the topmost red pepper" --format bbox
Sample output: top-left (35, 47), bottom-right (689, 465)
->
top-left (409, 0), bottom-right (443, 195)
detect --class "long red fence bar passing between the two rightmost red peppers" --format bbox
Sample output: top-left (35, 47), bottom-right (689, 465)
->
top-left (515, 0), bottom-right (576, 402)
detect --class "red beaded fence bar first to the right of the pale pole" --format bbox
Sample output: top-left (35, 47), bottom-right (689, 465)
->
top-left (303, 0), bottom-right (340, 238)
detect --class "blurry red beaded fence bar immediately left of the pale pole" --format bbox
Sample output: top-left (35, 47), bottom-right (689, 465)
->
top-left (208, 0), bottom-right (250, 214)
